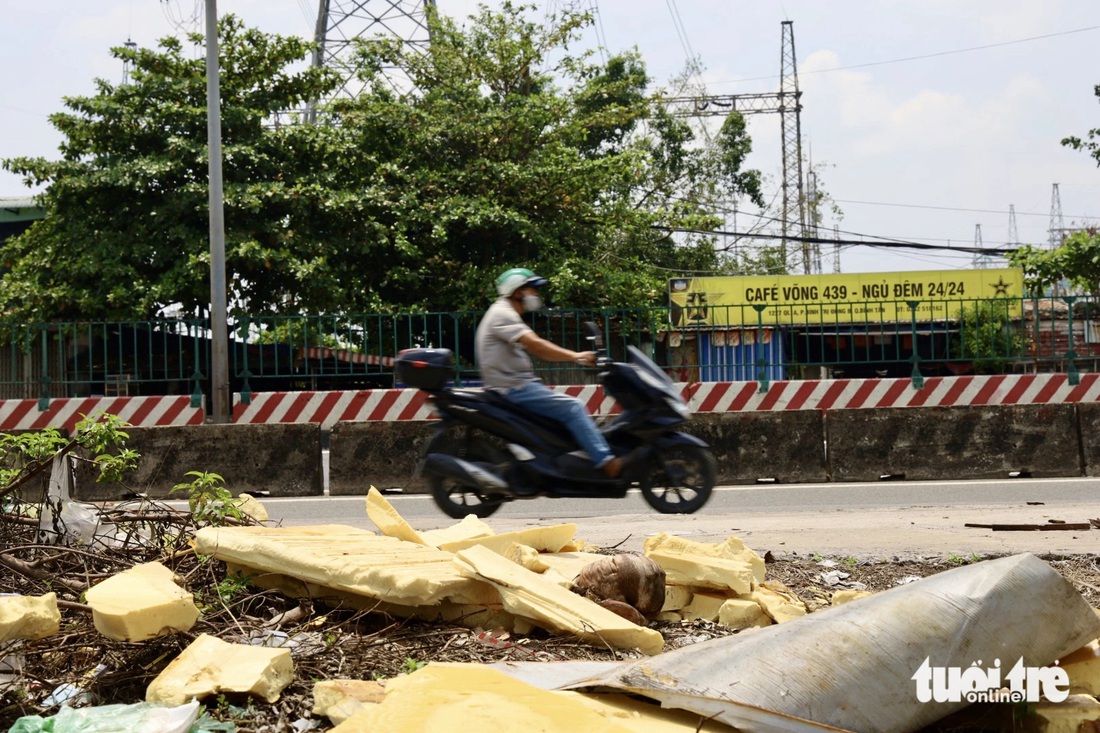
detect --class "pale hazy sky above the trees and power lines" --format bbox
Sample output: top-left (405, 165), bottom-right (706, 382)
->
top-left (0, 0), bottom-right (1100, 274)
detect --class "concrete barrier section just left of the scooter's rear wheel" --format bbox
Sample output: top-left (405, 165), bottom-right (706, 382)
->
top-left (329, 420), bottom-right (438, 496)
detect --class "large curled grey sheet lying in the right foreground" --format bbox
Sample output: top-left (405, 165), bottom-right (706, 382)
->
top-left (570, 554), bottom-right (1100, 733)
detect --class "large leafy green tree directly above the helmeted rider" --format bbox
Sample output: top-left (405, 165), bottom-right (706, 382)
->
top-left (333, 3), bottom-right (759, 309)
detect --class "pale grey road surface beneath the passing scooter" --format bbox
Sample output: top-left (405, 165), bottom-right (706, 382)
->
top-left (240, 479), bottom-right (1100, 559)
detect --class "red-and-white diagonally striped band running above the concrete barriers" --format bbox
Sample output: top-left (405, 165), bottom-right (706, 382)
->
top-left (0, 373), bottom-right (1100, 430)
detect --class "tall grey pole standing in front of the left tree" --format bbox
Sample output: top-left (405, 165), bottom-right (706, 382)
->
top-left (206, 0), bottom-right (231, 424)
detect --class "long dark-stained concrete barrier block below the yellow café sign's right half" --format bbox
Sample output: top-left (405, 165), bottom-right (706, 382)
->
top-left (825, 404), bottom-right (1084, 481)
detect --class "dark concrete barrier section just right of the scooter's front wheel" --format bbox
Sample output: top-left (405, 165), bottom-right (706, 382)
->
top-left (688, 409), bottom-right (826, 484)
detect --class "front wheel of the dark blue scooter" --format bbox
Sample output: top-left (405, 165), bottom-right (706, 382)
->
top-left (638, 446), bottom-right (718, 514)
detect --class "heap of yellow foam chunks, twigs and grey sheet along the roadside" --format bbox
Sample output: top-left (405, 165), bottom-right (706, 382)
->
top-left (0, 482), bottom-right (1100, 733)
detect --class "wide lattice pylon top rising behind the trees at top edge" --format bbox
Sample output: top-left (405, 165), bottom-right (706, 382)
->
top-left (310, 0), bottom-right (436, 113)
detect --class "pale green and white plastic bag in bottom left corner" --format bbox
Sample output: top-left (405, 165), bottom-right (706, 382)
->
top-left (8, 700), bottom-right (203, 733)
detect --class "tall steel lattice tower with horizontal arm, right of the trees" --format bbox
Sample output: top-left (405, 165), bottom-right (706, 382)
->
top-left (666, 21), bottom-right (813, 274)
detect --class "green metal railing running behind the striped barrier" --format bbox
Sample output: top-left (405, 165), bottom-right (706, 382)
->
top-left (0, 295), bottom-right (1100, 408)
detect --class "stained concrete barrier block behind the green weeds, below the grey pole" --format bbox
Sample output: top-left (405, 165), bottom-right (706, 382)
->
top-left (76, 423), bottom-right (325, 501)
